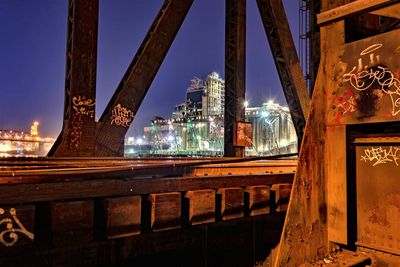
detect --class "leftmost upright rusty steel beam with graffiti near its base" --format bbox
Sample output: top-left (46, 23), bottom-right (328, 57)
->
top-left (48, 0), bottom-right (99, 157)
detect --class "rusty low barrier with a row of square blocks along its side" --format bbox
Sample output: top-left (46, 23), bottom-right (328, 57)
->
top-left (0, 159), bottom-right (294, 262)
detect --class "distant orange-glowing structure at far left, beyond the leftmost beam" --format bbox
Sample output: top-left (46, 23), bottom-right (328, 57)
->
top-left (0, 121), bottom-right (55, 157)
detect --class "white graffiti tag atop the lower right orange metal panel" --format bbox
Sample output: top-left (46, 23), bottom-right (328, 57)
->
top-left (361, 146), bottom-right (400, 166)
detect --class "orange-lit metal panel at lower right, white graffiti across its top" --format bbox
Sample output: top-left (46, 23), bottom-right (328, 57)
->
top-left (356, 143), bottom-right (400, 254)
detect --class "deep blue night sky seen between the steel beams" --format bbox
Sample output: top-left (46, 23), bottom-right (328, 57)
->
top-left (0, 0), bottom-right (299, 137)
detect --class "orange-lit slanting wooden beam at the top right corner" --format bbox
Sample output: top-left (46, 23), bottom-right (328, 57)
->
top-left (317, 0), bottom-right (400, 24)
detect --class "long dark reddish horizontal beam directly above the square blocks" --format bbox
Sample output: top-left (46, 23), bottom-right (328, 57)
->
top-left (0, 173), bottom-right (294, 204)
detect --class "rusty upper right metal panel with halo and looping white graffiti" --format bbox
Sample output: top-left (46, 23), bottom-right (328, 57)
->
top-left (327, 30), bottom-right (400, 125)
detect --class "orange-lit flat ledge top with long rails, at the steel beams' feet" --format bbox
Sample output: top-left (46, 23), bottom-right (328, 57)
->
top-left (0, 158), bottom-right (297, 184)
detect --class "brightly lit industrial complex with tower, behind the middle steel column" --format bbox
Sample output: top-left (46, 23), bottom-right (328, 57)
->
top-left (125, 72), bottom-right (297, 156)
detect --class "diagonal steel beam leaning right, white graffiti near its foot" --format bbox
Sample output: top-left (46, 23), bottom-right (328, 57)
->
top-left (95, 0), bottom-right (193, 156)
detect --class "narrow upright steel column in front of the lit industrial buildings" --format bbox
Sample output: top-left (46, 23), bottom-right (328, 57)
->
top-left (224, 0), bottom-right (246, 157)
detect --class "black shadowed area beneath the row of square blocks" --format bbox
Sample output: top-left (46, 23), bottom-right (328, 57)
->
top-left (0, 213), bottom-right (285, 267)
